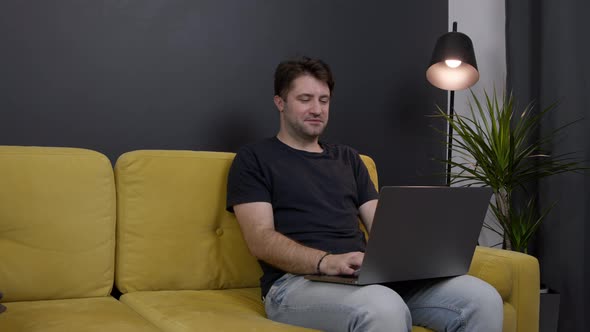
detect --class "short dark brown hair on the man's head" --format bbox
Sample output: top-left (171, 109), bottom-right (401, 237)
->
top-left (275, 56), bottom-right (334, 99)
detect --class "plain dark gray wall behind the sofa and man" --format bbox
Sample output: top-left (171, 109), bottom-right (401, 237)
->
top-left (0, 0), bottom-right (448, 184)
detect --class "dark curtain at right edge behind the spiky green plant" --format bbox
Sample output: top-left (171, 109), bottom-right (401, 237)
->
top-left (506, 0), bottom-right (590, 331)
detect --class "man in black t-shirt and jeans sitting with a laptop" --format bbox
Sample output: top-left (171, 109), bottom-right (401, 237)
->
top-left (227, 57), bottom-right (503, 332)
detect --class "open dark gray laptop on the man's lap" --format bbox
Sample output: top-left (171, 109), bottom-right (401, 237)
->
top-left (305, 186), bottom-right (492, 285)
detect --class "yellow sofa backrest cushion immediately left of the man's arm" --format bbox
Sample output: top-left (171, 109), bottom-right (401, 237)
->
top-left (115, 150), bottom-right (261, 293)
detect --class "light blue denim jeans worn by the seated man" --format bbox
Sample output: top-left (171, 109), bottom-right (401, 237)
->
top-left (265, 274), bottom-right (503, 332)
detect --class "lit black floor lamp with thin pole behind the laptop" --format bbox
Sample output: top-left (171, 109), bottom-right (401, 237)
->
top-left (426, 22), bottom-right (479, 186)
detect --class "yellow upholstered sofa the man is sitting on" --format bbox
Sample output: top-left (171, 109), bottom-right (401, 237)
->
top-left (0, 147), bottom-right (539, 332)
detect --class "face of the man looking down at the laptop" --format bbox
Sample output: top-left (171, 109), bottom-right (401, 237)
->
top-left (275, 75), bottom-right (330, 140)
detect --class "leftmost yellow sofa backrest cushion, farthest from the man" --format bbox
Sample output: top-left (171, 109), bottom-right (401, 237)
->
top-left (0, 146), bottom-right (116, 302)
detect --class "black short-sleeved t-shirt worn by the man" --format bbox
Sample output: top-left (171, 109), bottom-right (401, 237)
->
top-left (227, 137), bottom-right (378, 296)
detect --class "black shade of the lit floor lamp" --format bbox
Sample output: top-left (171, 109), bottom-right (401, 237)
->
top-left (426, 32), bottom-right (479, 91)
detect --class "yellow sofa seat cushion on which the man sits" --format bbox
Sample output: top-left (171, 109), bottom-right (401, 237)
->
top-left (120, 288), bottom-right (320, 332)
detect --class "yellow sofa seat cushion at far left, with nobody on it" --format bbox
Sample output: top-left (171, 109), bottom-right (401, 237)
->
top-left (0, 296), bottom-right (158, 332)
